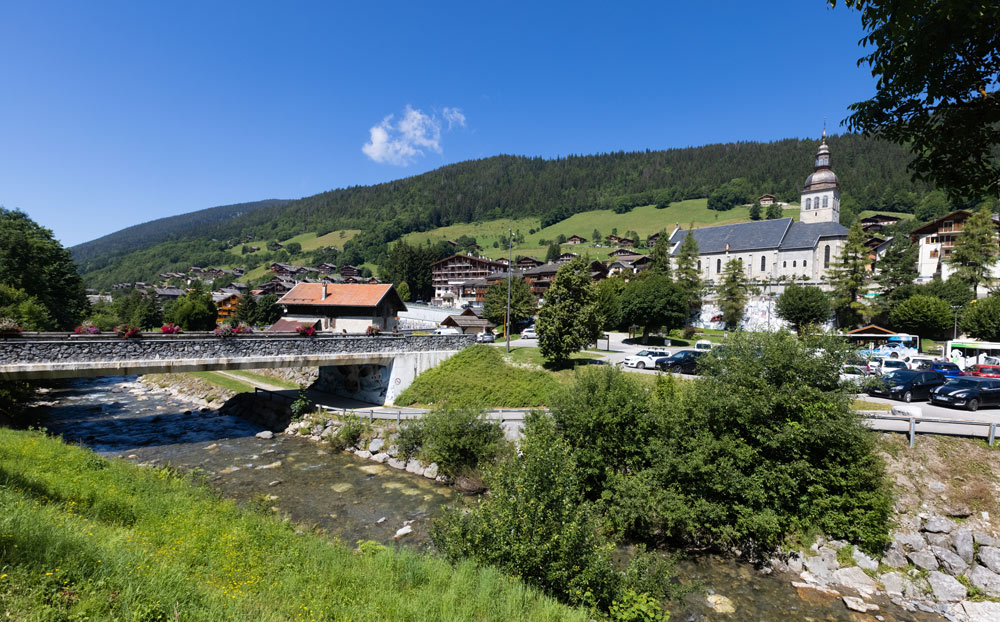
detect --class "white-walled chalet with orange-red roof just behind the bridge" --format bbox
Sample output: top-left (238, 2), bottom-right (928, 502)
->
top-left (278, 283), bottom-right (406, 334)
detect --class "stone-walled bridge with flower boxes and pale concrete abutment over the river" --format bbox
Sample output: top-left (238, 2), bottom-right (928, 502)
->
top-left (0, 333), bottom-right (475, 404)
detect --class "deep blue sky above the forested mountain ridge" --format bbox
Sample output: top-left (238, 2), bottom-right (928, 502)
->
top-left (0, 0), bottom-right (874, 245)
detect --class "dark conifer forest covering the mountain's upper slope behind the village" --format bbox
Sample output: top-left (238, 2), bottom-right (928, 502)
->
top-left (74, 135), bottom-right (930, 287)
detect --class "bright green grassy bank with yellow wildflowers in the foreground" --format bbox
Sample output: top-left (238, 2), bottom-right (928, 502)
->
top-left (0, 429), bottom-right (588, 622)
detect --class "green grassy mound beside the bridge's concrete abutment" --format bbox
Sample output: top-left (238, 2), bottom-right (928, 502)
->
top-left (396, 345), bottom-right (558, 408)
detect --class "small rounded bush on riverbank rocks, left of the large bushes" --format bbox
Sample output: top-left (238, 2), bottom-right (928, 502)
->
top-left (421, 408), bottom-right (503, 477)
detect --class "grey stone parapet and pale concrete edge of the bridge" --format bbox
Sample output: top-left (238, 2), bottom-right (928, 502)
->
top-left (0, 333), bottom-right (475, 380)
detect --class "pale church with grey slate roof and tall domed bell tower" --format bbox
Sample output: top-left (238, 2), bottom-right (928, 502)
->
top-left (670, 135), bottom-right (847, 282)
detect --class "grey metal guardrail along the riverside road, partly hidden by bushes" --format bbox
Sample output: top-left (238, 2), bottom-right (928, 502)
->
top-left (254, 387), bottom-right (998, 447)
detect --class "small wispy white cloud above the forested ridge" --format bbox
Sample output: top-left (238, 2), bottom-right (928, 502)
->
top-left (361, 105), bottom-right (465, 166)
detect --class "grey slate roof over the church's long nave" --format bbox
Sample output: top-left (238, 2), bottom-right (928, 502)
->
top-left (670, 218), bottom-right (847, 255)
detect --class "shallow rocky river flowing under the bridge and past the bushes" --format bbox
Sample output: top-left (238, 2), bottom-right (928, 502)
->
top-left (35, 376), bottom-right (944, 622)
